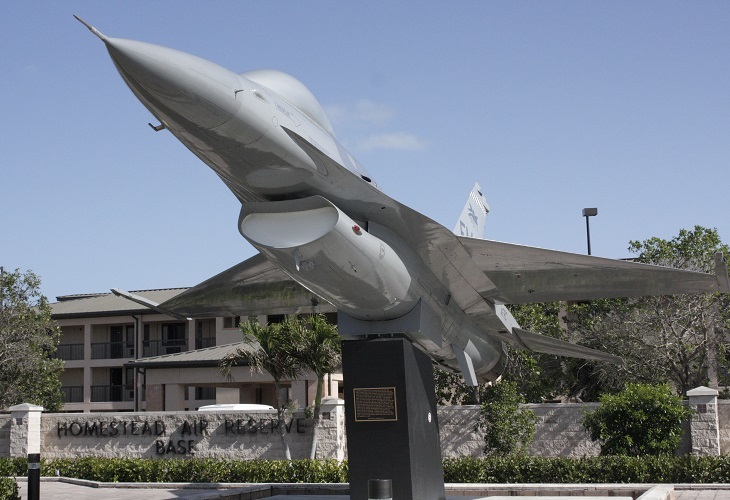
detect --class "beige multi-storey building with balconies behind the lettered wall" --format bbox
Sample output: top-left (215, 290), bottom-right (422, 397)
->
top-left (52, 288), bottom-right (342, 412)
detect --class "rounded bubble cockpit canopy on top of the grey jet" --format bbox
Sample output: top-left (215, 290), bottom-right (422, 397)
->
top-left (241, 69), bottom-right (335, 136)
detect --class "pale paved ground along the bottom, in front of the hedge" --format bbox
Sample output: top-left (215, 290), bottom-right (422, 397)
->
top-left (12, 478), bottom-right (730, 500)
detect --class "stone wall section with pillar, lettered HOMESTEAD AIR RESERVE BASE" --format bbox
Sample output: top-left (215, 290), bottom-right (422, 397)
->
top-left (41, 407), bottom-right (345, 460)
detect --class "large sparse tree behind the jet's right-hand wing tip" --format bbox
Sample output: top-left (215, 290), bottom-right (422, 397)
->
top-left (569, 226), bottom-right (730, 395)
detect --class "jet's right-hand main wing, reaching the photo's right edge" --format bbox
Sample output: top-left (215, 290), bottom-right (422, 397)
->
top-left (459, 237), bottom-right (730, 304)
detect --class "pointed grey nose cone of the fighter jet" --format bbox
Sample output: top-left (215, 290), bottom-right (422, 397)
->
top-left (103, 37), bottom-right (241, 129)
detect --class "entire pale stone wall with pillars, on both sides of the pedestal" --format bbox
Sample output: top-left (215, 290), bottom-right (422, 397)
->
top-left (0, 388), bottom-right (730, 460)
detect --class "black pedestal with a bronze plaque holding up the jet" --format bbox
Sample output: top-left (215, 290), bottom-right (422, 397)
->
top-left (342, 338), bottom-right (446, 500)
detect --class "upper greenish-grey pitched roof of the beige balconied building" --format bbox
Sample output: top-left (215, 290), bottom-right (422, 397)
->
top-left (51, 288), bottom-right (187, 319)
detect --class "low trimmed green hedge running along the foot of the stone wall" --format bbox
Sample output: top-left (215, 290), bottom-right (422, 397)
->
top-left (0, 455), bottom-right (730, 484)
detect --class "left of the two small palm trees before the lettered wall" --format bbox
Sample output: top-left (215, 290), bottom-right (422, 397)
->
top-left (220, 316), bottom-right (303, 460)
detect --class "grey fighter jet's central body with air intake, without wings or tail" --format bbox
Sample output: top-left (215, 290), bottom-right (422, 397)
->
top-left (90, 28), bottom-right (506, 383)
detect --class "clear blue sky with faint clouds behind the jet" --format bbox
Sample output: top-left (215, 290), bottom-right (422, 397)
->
top-left (0, 0), bottom-right (730, 299)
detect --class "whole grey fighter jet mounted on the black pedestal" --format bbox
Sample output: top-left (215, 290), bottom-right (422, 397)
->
top-left (77, 18), bottom-right (730, 385)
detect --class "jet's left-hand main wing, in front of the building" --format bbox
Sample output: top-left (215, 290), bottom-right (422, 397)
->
top-left (159, 254), bottom-right (323, 318)
